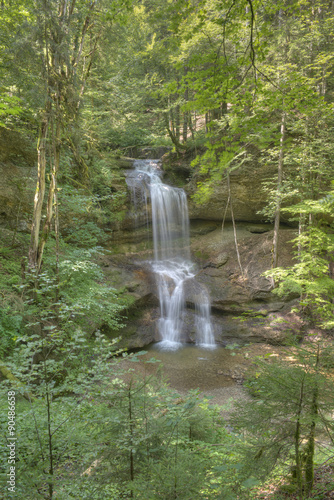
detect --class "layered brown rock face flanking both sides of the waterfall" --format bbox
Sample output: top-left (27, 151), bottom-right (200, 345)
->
top-left (102, 221), bottom-right (302, 348)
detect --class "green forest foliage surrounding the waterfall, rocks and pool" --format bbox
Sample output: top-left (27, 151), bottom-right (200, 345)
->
top-left (0, 0), bottom-right (334, 500)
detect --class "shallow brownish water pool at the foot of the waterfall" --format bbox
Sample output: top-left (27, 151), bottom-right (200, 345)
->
top-left (123, 343), bottom-right (285, 410)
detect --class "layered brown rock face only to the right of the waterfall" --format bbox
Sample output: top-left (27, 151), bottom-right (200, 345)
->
top-left (188, 224), bottom-right (302, 344)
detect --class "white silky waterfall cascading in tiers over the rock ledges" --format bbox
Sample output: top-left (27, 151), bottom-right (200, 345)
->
top-left (127, 160), bottom-right (215, 350)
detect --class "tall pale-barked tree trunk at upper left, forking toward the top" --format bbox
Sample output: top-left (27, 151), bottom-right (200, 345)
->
top-left (28, 0), bottom-right (101, 274)
